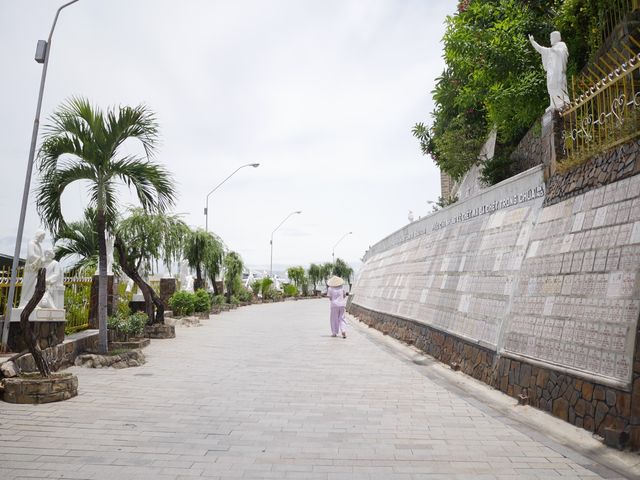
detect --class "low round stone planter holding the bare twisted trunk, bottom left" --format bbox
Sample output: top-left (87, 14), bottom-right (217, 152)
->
top-left (2, 373), bottom-right (78, 404)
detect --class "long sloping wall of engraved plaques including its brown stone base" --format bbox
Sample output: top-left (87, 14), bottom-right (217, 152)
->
top-left (350, 167), bottom-right (640, 448)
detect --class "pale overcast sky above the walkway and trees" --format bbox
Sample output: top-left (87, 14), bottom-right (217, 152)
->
top-left (0, 0), bottom-right (457, 267)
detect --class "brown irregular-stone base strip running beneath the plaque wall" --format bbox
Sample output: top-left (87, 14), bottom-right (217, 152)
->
top-left (348, 301), bottom-right (640, 449)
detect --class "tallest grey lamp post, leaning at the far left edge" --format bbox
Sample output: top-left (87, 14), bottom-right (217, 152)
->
top-left (0, 0), bottom-right (78, 350)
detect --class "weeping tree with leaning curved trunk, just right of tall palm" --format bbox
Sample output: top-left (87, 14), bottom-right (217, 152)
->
top-left (115, 208), bottom-right (191, 324)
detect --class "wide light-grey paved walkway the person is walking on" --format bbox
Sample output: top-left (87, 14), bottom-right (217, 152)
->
top-left (0, 300), bottom-right (640, 480)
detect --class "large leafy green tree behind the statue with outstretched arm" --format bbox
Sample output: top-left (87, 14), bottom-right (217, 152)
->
top-left (412, 0), bottom-right (607, 184)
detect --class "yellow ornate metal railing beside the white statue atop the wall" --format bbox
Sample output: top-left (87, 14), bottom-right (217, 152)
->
top-left (559, 37), bottom-right (640, 169)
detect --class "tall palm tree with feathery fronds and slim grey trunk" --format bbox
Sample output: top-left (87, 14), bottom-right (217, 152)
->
top-left (36, 98), bottom-right (175, 353)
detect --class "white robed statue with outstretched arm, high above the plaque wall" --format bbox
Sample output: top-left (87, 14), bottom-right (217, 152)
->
top-left (529, 32), bottom-right (569, 110)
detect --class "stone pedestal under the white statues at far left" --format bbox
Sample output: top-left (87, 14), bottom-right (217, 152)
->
top-left (8, 308), bottom-right (66, 352)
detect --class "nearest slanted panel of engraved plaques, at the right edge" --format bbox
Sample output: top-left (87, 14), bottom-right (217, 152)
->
top-left (504, 176), bottom-right (640, 387)
